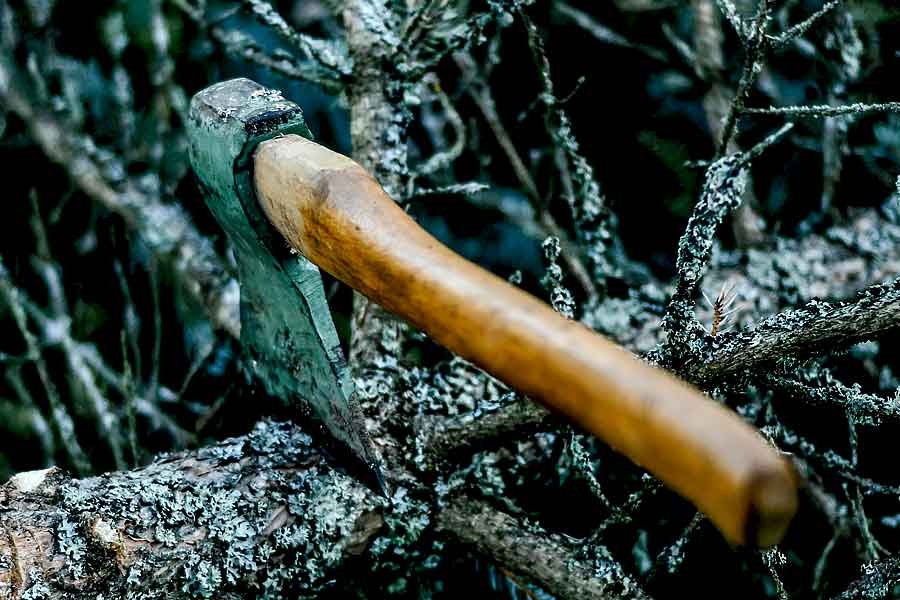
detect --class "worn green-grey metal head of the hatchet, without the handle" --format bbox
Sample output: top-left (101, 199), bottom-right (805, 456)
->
top-left (188, 79), bottom-right (384, 491)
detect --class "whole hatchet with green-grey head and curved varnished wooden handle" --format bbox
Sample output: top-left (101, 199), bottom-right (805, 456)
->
top-left (189, 79), bottom-right (797, 546)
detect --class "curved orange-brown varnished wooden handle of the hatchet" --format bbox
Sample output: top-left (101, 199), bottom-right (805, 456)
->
top-left (254, 135), bottom-right (797, 546)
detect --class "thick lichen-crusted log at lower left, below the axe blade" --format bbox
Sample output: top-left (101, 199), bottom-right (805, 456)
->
top-left (0, 423), bottom-right (383, 600)
